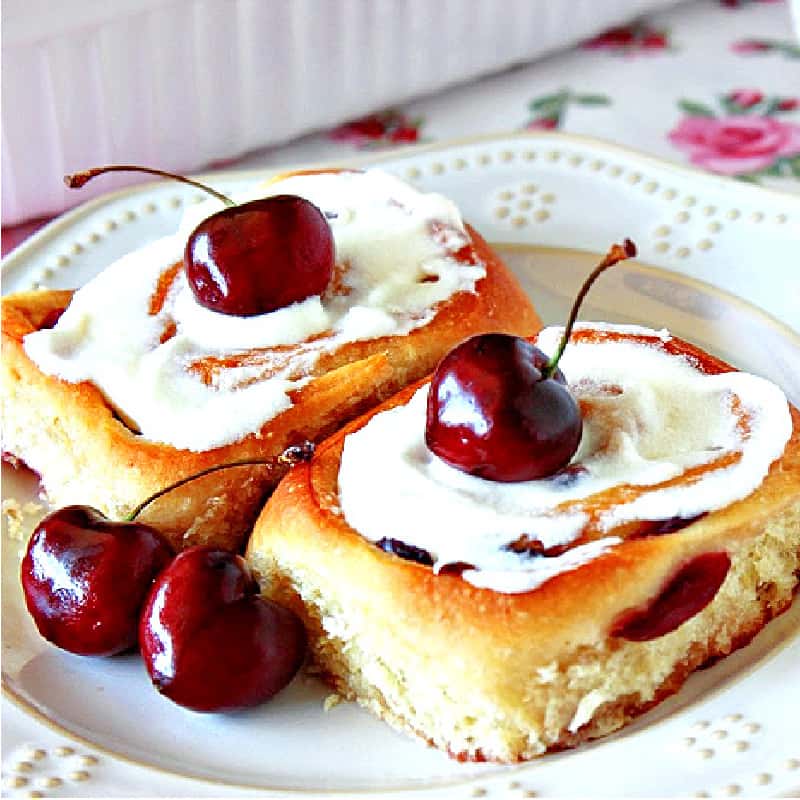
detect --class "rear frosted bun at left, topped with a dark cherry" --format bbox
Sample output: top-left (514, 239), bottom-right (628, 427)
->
top-left (2, 170), bottom-right (541, 549)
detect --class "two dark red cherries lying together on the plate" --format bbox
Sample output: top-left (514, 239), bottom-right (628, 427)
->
top-left (21, 506), bottom-right (306, 711)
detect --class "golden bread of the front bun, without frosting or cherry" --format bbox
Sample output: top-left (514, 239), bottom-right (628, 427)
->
top-left (247, 366), bottom-right (800, 762)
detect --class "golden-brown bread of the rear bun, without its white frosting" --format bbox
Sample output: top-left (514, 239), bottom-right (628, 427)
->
top-left (2, 229), bottom-right (541, 548)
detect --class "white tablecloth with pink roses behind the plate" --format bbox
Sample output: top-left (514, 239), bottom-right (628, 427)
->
top-left (3, 0), bottom-right (800, 252)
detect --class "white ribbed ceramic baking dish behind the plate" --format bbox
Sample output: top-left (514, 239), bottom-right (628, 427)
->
top-left (2, 0), bottom-right (677, 225)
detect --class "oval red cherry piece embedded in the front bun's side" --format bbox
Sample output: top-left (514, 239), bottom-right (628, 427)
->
top-left (611, 552), bottom-right (731, 642)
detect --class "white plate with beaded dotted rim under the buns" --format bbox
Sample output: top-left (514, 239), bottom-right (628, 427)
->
top-left (2, 134), bottom-right (800, 798)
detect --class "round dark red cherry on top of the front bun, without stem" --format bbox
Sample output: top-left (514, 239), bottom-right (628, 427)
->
top-left (425, 333), bottom-right (583, 481)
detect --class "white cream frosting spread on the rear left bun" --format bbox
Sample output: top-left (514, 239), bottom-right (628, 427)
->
top-left (24, 170), bottom-right (485, 451)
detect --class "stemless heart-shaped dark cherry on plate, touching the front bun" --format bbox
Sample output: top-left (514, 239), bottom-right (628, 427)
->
top-left (139, 546), bottom-right (306, 711)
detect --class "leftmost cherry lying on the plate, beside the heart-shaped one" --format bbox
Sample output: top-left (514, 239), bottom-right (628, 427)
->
top-left (21, 506), bottom-right (172, 656)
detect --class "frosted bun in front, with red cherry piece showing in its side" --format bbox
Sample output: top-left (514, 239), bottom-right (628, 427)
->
top-left (246, 325), bottom-right (800, 762)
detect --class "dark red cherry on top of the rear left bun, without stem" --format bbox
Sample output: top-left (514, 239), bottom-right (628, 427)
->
top-left (183, 195), bottom-right (334, 317)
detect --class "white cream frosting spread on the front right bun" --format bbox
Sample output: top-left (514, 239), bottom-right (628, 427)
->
top-left (339, 325), bottom-right (791, 593)
